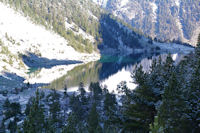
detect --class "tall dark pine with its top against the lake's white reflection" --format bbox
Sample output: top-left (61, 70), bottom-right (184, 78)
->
top-left (123, 66), bottom-right (156, 133)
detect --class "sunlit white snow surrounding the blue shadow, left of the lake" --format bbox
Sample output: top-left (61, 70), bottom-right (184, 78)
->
top-left (0, 2), bottom-right (100, 83)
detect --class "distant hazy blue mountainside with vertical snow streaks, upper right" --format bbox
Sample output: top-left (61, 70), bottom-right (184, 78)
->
top-left (94, 0), bottom-right (200, 45)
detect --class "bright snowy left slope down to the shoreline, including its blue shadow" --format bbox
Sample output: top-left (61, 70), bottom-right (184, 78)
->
top-left (0, 3), bottom-right (99, 84)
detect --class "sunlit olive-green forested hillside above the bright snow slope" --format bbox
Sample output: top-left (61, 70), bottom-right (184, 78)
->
top-left (2, 0), bottom-right (101, 52)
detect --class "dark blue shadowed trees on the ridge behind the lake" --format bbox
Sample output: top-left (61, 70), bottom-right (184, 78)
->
top-left (100, 14), bottom-right (141, 48)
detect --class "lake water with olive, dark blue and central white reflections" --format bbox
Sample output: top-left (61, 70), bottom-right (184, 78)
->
top-left (48, 54), bottom-right (184, 91)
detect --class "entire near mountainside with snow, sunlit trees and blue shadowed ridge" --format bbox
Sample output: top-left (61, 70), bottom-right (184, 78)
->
top-left (0, 0), bottom-right (155, 83)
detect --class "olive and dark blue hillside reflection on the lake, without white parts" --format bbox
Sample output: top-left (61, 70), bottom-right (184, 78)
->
top-left (50, 54), bottom-right (184, 89)
